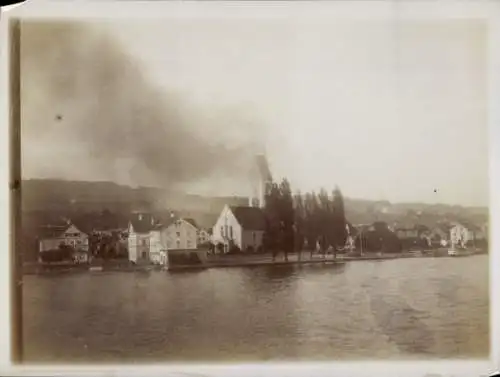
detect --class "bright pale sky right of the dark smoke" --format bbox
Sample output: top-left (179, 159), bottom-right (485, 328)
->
top-left (23, 19), bottom-right (488, 205)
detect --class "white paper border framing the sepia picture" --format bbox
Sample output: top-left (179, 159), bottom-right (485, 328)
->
top-left (0, 0), bottom-right (500, 377)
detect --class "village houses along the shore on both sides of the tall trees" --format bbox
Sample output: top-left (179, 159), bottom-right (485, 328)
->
top-left (39, 200), bottom-right (488, 264)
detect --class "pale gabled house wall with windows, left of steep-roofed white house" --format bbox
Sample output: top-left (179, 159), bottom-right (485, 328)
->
top-left (160, 219), bottom-right (198, 250)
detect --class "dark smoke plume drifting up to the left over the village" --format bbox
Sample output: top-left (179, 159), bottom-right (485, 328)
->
top-left (21, 21), bottom-right (264, 188)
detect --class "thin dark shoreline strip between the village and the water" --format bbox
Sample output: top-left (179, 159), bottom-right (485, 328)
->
top-left (23, 251), bottom-right (488, 275)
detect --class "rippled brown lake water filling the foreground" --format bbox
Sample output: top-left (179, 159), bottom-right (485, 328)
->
top-left (23, 255), bottom-right (489, 362)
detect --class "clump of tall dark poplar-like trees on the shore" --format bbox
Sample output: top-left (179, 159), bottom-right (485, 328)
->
top-left (263, 178), bottom-right (348, 260)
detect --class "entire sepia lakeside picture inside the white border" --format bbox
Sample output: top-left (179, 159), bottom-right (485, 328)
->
top-left (5, 2), bottom-right (491, 373)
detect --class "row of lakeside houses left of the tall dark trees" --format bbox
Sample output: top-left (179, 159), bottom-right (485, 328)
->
top-left (38, 206), bottom-right (265, 264)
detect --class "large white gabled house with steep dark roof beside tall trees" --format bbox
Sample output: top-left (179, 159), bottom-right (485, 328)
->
top-left (213, 205), bottom-right (266, 253)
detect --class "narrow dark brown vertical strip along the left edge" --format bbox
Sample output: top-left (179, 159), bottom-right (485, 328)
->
top-left (9, 19), bottom-right (23, 363)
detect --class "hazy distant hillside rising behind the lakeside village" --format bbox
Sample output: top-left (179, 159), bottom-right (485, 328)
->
top-left (20, 179), bottom-right (488, 260)
